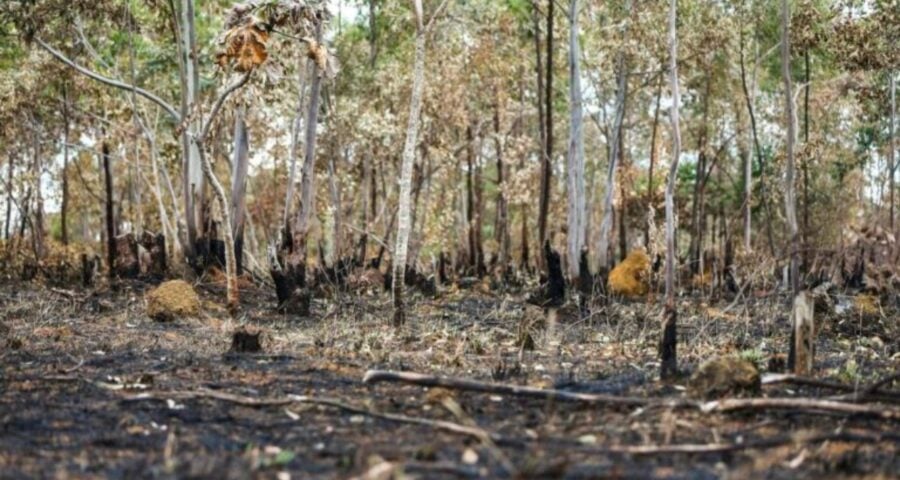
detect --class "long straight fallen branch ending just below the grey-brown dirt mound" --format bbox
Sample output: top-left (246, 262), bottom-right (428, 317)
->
top-left (363, 370), bottom-right (700, 407)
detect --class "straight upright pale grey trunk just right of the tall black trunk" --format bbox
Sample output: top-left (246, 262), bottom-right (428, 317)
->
top-left (566, 0), bottom-right (589, 281)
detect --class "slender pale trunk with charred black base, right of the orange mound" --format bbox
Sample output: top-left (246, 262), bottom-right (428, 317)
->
top-left (660, 0), bottom-right (681, 378)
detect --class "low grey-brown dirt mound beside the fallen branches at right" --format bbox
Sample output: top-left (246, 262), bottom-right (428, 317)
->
top-left (688, 356), bottom-right (760, 399)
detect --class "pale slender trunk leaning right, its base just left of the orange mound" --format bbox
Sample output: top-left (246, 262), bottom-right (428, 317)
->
top-left (597, 0), bottom-right (632, 272)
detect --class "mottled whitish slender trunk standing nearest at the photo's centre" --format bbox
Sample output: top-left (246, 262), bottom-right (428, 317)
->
top-left (391, 0), bottom-right (426, 327)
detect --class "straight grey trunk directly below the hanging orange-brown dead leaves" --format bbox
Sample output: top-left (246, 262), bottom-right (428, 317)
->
top-left (231, 105), bottom-right (250, 275)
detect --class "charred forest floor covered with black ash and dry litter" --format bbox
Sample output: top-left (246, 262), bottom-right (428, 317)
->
top-left (0, 282), bottom-right (900, 479)
